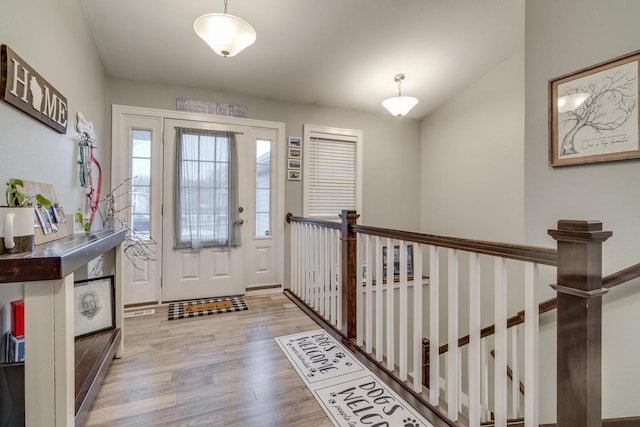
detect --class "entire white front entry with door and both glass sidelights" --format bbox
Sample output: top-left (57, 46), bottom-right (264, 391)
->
top-left (112, 106), bottom-right (285, 304)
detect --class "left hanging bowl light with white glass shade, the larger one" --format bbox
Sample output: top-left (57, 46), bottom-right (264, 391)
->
top-left (193, 0), bottom-right (256, 58)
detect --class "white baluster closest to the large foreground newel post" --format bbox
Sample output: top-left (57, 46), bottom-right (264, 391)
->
top-left (524, 262), bottom-right (540, 427)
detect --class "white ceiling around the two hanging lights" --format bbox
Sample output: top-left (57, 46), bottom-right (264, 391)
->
top-left (82, 0), bottom-right (524, 118)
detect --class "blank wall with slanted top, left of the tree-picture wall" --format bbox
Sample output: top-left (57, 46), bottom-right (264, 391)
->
top-left (420, 52), bottom-right (524, 243)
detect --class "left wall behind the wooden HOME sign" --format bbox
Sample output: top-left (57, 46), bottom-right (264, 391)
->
top-left (0, 0), bottom-right (110, 342)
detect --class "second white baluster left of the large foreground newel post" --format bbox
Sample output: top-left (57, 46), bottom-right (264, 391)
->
top-left (493, 257), bottom-right (508, 427)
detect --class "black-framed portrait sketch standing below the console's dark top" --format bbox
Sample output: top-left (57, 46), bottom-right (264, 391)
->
top-left (74, 276), bottom-right (116, 338)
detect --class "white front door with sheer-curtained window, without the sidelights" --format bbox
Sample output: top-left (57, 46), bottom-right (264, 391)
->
top-left (162, 120), bottom-right (249, 301)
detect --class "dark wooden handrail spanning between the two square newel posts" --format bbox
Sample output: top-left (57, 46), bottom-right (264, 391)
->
top-left (353, 225), bottom-right (558, 266)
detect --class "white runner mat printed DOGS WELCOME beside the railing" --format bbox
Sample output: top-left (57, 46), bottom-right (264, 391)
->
top-left (275, 329), bottom-right (433, 427)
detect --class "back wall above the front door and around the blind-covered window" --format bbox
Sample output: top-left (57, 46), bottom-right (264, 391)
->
top-left (108, 79), bottom-right (420, 230)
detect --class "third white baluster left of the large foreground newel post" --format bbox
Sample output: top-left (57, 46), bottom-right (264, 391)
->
top-left (468, 253), bottom-right (482, 427)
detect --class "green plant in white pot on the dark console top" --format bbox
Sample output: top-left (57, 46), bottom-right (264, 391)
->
top-left (0, 178), bottom-right (51, 254)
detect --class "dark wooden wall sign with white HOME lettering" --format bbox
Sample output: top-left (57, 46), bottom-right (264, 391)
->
top-left (0, 44), bottom-right (68, 133)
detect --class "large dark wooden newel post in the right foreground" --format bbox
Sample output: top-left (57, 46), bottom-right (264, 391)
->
top-left (549, 220), bottom-right (612, 427)
